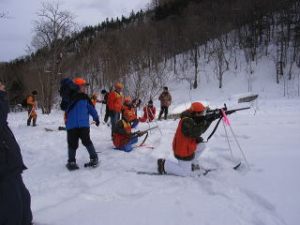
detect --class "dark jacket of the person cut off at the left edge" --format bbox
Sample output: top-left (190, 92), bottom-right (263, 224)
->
top-left (0, 91), bottom-right (26, 183)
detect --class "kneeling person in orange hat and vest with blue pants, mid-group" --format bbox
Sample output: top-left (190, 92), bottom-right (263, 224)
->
top-left (113, 110), bottom-right (145, 152)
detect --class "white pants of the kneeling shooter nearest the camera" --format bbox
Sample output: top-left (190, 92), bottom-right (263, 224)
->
top-left (165, 143), bottom-right (206, 177)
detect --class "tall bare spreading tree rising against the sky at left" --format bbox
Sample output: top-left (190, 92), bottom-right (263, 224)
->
top-left (32, 1), bottom-right (75, 113)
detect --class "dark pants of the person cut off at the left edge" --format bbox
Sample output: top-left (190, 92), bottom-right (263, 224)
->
top-left (0, 174), bottom-right (32, 225)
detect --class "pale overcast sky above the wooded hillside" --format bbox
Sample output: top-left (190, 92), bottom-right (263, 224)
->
top-left (0, 0), bottom-right (150, 62)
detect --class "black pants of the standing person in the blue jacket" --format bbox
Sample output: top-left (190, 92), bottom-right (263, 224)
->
top-left (67, 127), bottom-right (98, 162)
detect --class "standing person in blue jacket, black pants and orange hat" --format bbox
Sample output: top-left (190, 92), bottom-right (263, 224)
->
top-left (66, 78), bottom-right (100, 170)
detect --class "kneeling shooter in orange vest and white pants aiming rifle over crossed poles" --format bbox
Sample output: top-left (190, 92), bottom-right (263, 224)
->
top-left (157, 102), bottom-right (220, 176)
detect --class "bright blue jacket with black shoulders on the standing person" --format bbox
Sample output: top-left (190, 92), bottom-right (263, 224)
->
top-left (66, 94), bottom-right (99, 130)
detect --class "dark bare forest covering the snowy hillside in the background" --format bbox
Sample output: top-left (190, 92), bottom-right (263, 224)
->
top-left (0, 0), bottom-right (300, 113)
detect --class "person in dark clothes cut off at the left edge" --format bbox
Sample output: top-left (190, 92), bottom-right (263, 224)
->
top-left (0, 82), bottom-right (32, 225)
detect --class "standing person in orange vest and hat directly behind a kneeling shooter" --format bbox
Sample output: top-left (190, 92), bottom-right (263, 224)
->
top-left (107, 82), bottom-right (124, 134)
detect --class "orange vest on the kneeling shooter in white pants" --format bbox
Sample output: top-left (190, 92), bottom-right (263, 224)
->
top-left (173, 118), bottom-right (197, 158)
